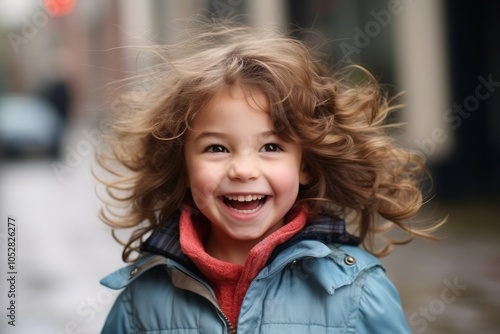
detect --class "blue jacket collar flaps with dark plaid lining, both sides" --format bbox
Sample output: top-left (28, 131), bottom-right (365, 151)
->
top-left (101, 209), bottom-right (364, 294)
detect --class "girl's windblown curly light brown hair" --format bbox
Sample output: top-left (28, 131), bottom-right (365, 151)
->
top-left (97, 18), bottom-right (442, 261)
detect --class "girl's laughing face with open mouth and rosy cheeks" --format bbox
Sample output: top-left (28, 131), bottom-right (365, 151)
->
top-left (184, 87), bottom-right (307, 248)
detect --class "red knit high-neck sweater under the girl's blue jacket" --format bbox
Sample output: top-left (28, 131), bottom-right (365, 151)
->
top-left (179, 207), bottom-right (307, 326)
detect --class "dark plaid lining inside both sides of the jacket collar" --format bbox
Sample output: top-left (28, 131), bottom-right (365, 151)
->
top-left (141, 214), bottom-right (360, 270)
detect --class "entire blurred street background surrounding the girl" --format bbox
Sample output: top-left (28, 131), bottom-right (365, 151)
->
top-left (0, 0), bottom-right (500, 334)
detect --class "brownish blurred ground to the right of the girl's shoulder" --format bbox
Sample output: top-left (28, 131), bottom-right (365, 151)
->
top-left (383, 198), bottom-right (500, 334)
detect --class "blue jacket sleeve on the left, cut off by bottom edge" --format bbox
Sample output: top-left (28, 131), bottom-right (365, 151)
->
top-left (101, 289), bottom-right (133, 334)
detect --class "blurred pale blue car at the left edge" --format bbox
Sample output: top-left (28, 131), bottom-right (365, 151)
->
top-left (0, 94), bottom-right (64, 158)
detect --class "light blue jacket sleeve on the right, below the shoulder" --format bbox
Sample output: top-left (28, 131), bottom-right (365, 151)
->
top-left (356, 266), bottom-right (411, 334)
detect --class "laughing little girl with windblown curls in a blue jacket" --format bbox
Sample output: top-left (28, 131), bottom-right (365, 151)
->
top-left (99, 18), bottom-right (438, 334)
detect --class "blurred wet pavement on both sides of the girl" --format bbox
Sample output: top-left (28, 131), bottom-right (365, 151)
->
top-left (0, 159), bottom-right (500, 334)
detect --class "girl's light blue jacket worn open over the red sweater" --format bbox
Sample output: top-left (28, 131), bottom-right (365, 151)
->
top-left (101, 215), bottom-right (411, 334)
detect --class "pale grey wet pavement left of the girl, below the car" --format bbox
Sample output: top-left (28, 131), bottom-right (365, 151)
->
top-left (0, 157), bottom-right (122, 334)
